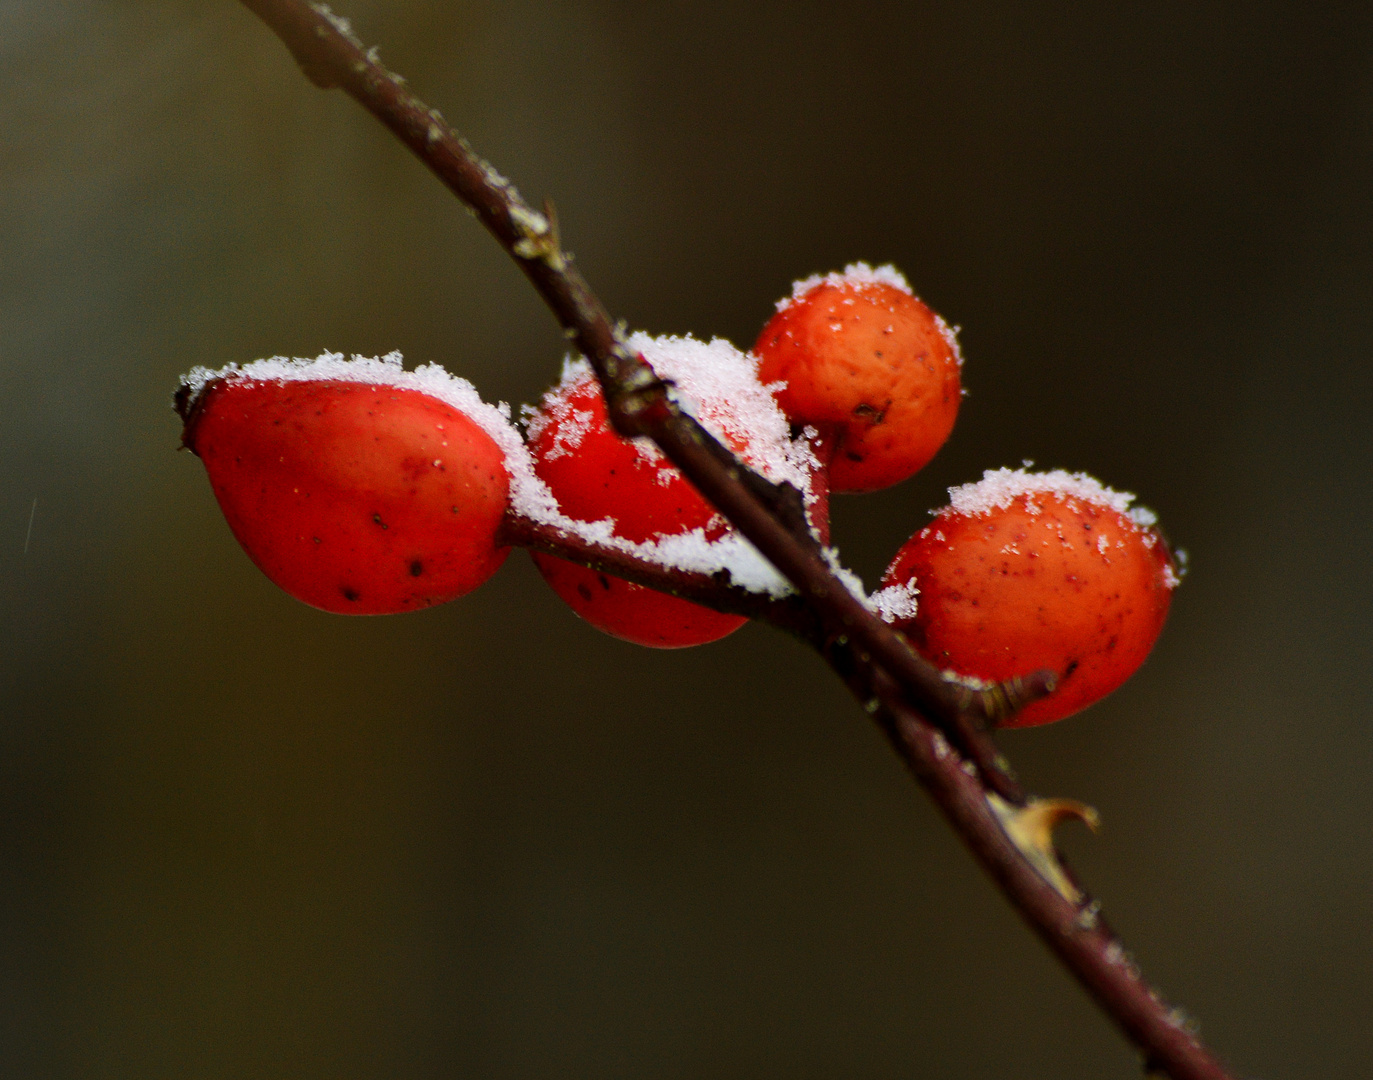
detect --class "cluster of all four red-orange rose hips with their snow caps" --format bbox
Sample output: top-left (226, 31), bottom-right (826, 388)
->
top-left (177, 263), bottom-right (1177, 725)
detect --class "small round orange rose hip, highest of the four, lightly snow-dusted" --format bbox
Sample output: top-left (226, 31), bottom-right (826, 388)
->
top-left (754, 262), bottom-right (962, 491)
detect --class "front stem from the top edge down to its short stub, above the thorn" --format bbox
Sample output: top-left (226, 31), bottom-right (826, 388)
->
top-left (243, 0), bottom-right (1027, 784)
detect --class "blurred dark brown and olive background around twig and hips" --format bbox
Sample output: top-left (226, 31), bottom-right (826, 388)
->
top-left (0, 0), bottom-right (1373, 1080)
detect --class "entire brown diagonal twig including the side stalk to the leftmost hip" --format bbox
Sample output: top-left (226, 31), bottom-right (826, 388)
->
top-left (230, 0), bottom-right (1229, 1080)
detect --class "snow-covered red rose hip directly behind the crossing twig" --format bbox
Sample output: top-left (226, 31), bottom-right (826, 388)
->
top-left (529, 333), bottom-right (809, 649)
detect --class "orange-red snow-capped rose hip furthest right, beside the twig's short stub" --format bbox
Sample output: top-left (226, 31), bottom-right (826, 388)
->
top-left (879, 469), bottom-right (1178, 727)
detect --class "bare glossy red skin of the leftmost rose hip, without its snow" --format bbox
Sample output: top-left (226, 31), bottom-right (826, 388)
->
top-left (183, 377), bottom-right (509, 615)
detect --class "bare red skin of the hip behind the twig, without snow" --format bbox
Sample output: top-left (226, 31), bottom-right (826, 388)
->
top-left (529, 380), bottom-right (747, 649)
